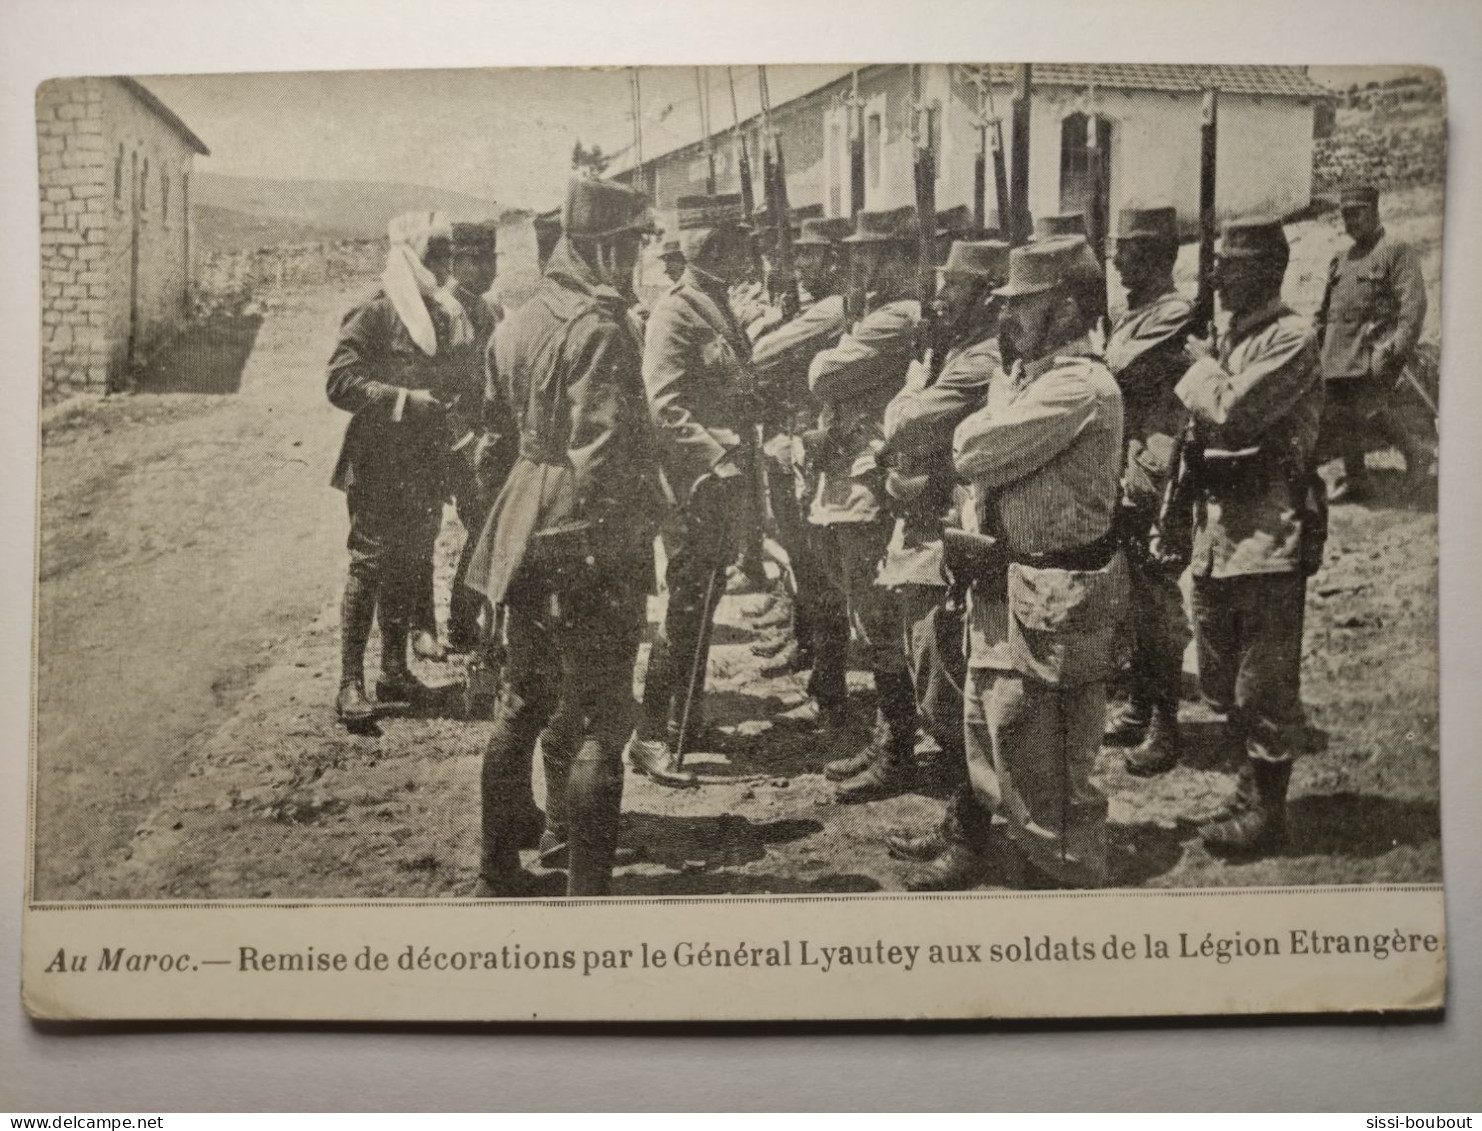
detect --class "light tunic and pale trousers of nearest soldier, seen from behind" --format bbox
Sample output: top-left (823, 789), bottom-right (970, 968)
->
top-left (953, 339), bottom-right (1128, 886)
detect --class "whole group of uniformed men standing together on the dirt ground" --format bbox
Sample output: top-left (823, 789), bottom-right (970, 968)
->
top-left (329, 179), bottom-right (1424, 895)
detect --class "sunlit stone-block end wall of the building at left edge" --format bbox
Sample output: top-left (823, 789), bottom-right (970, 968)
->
top-left (36, 79), bottom-right (110, 403)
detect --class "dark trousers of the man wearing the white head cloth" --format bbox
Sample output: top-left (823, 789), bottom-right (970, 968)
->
top-left (341, 483), bottom-right (442, 682)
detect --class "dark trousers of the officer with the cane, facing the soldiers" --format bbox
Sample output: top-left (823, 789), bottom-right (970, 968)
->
top-left (639, 477), bottom-right (747, 740)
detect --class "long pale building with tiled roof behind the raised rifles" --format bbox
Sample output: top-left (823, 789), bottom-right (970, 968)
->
top-left (609, 64), bottom-right (1331, 243)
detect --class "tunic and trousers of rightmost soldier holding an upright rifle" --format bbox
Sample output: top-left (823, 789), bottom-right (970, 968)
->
top-left (1175, 299), bottom-right (1325, 762)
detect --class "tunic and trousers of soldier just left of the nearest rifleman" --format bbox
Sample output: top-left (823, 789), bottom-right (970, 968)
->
top-left (877, 338), bottom-right (1000, 766)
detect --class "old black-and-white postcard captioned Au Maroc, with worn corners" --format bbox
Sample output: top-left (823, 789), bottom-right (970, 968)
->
top-left (22, 62), bottom-right (1446, 1021)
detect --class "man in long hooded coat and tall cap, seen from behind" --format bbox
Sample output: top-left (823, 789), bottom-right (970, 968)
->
top-left (468, 179), bottom-right (658, 895)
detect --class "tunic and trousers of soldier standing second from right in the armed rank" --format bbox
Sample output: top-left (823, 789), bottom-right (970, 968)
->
top-left (1104, 291), bottom-right (1193, 712)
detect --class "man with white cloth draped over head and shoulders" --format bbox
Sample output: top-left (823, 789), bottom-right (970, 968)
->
top-left (325, 212), bottom-right (473, 728)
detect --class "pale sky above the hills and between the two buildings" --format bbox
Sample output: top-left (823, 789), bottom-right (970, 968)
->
top-left (139, 67), bottom-right (849, 208)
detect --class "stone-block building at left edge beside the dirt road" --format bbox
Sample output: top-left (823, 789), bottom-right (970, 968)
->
top-left (36, 77), bottom-right (209, 403)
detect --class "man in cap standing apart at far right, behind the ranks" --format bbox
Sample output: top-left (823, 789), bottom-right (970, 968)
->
top-left (1317, 185), bottom-right (1430, 503)
